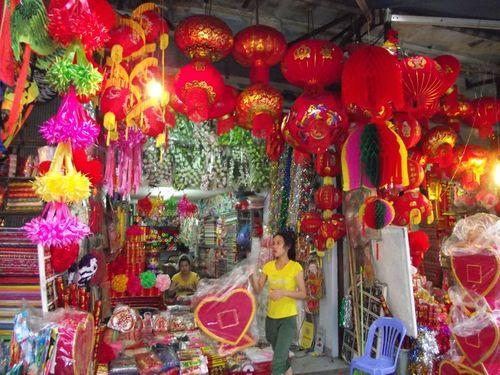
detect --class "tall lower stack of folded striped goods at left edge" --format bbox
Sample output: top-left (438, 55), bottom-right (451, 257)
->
top-left (0, 228), bottom-right (42, 336)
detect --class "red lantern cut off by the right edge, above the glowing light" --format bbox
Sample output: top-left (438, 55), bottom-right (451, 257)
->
top-left (464, 97), bottom-right (500, 137)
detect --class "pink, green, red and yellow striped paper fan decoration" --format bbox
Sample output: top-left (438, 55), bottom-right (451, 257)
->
top-left (341, 124), bottom-right (408, 191)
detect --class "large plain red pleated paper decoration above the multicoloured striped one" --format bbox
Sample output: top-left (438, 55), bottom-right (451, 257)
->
top-left (342, 46), bottom-right (404, 121)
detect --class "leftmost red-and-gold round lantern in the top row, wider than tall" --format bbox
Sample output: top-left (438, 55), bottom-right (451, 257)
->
top-left (175, 15), bottom-right (233, 62)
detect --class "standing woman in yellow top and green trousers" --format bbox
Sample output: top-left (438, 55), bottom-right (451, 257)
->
top-left (250, 230), bottom-right (306, 375)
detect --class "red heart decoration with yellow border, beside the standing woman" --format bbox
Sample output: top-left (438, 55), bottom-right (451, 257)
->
top-left (194, 288), bottom-right (255, 345)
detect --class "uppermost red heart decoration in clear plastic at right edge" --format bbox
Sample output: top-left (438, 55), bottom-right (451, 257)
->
top-left (451, 249), bottom-right (500, 296)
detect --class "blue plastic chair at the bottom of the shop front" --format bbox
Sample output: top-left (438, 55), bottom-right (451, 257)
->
top-left (350, 318), bottom-right (406, 375)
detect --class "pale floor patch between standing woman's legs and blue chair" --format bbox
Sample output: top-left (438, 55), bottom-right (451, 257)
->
top-left (292, 352), bottom-right (349, 375)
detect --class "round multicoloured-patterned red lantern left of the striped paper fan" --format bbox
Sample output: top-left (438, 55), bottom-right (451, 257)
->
top-left (282, 91), bottom-right (346, 154)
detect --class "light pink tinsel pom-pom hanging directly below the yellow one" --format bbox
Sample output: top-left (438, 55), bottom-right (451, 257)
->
top-left (24, 202), bottom-right (90, 247)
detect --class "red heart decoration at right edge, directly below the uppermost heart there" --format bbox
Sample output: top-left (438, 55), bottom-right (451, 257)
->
top-left (453, 316), bottom-right (500, 366)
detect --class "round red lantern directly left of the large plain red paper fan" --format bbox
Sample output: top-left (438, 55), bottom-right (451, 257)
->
top-left (281, 39), bottom-right (343, 91)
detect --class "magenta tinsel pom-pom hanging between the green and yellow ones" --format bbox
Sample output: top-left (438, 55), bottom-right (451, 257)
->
top-left (40, 87), bottom-right (99, 148)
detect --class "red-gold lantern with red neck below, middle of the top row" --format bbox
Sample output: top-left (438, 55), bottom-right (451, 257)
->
top-left (233, 25), bottom-right (286, 84)
